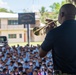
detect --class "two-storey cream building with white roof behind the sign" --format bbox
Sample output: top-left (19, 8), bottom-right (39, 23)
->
top-left (0, 12), bottom-right (45, 43)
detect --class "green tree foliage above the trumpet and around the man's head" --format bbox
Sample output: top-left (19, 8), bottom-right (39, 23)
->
top-left (39, 0), bottom-right (76, 23)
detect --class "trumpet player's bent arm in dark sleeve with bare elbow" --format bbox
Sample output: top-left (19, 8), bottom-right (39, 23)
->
top-left (39, 29), bottom-right (53, 58)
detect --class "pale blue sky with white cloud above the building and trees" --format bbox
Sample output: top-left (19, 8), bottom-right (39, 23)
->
top-left (0, 0), bottom-right (62, 13)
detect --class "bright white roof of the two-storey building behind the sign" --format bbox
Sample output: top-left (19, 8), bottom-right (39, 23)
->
top-left (0, 12), bottom-right (39, 19)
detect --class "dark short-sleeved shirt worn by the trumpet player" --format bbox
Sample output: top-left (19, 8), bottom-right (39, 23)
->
top-left (41, 20), bottom-right (76, 73)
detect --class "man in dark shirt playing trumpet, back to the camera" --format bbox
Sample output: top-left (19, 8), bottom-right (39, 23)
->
top-left (39, 3), bottom-right (76, 75)
